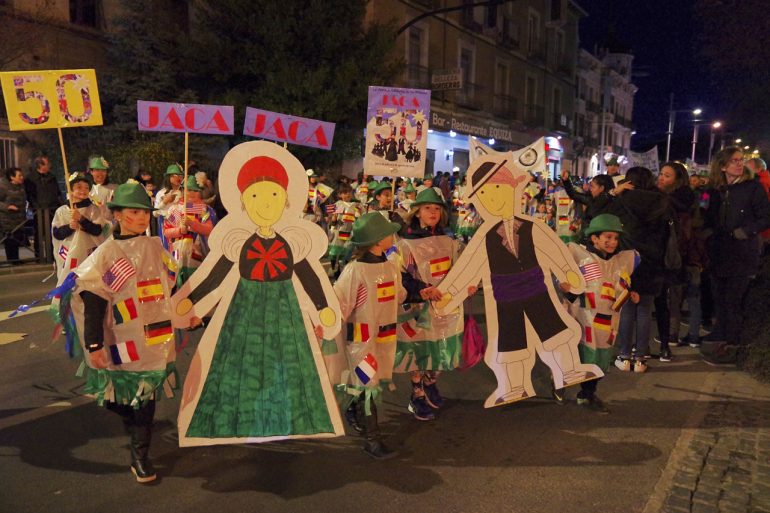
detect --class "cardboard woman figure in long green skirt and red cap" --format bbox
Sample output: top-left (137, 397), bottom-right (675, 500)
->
top-left (173, 141), bottom-right (344, 446)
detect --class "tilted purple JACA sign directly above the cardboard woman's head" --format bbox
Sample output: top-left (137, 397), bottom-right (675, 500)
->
top-left (243, 107), bottom-right (335, 150)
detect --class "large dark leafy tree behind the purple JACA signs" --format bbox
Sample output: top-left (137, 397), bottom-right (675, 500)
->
top-left (182, 0), bottom-right (402, 172)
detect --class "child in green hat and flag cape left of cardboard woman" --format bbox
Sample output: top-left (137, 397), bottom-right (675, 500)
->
top-left (61, 183), bottom-right (176, 483)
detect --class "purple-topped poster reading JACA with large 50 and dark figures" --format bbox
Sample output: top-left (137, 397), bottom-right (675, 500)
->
top-left (364, 86), bottom-right (430, 178)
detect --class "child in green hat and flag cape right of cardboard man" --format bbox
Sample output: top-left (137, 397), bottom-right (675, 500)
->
top-left (563, 214), bottom-right (639, 413)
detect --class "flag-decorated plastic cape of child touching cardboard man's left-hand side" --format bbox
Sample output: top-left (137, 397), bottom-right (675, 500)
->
top-left (394, 235), bottom-right (464, 373)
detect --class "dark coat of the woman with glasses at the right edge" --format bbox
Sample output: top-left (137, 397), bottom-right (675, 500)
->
top-left (704, 180), bottom-right (770, 277)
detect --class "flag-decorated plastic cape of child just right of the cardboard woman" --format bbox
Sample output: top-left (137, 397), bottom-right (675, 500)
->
top-left (322, 261), bottom-right (406, 414)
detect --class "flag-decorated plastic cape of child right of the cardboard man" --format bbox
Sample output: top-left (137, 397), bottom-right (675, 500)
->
top-left (568, 243), bottom-right (638, 372)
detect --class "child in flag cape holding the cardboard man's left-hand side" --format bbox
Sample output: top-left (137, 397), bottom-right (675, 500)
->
top-left (394, 188), bottom-right (464, 420)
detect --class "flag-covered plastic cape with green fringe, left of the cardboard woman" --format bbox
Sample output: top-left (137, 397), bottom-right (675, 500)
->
top-left (48, 236), bottom-right (178, 408)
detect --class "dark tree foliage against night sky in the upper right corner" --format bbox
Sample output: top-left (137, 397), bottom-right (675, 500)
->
top-left (695, 0), bottom-right (770, 146)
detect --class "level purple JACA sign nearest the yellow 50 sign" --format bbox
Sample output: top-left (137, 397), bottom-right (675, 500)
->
top-left (136, 100), bottom-right (235, 135)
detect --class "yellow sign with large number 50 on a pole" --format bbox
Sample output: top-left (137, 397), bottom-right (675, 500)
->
top-left (0, 69), bottom-right (102, 131)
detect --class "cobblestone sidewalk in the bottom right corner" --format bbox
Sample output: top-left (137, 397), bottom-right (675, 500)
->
top-left (644, 369), bottom-right (770, 513)
